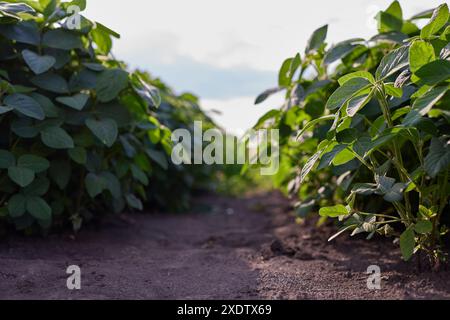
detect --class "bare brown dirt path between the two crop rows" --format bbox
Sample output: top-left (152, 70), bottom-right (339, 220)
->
top-left (0, 193), bottom-right (450, 299)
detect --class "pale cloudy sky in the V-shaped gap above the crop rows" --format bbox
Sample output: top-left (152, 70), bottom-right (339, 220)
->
top-left (85, 0), bottom-right (448, 134)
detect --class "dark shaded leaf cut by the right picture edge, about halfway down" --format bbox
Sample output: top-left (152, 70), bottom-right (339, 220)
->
top-left (424, 138), bottom-right (450, 178)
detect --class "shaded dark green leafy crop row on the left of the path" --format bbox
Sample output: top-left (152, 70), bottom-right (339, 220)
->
top-left (0, 0), bottom-right (215, 231)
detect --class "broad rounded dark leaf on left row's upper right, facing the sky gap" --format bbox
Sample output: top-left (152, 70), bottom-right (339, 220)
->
top-left (96, 69), bottom-right (128, 102)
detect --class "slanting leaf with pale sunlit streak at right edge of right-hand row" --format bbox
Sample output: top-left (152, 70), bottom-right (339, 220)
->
top-left (402, 86), bottom-right (449, 127)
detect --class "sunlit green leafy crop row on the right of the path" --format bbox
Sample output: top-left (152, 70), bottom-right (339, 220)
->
top-left (257, 1), bottom-right (450, 261)
